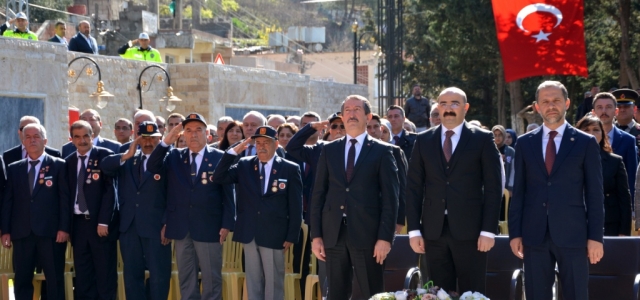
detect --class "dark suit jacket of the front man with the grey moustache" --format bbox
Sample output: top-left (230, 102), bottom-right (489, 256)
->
top-left (309, 135), bottom-right (400, 249)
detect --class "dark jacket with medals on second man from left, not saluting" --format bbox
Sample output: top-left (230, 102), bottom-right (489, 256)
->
top-left (65, 146), bottom-right (118, 242)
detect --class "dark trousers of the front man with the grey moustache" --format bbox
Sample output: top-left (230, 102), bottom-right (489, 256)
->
top-left (325, 219), bottom-right (384, 300)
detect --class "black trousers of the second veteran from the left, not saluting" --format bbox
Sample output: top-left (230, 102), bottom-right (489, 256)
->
top-left (73, 216), bottom-right (118, 300)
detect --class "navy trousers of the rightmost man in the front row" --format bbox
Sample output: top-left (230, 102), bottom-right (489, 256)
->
top-left (524, 230), bottom-right (589, 300)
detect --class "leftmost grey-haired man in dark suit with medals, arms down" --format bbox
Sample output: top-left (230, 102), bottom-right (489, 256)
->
top-left (2, 123), bottom-right (70, 300)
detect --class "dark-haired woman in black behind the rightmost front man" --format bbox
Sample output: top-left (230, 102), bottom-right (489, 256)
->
top-left (576, 116), bottom-right (631, 236)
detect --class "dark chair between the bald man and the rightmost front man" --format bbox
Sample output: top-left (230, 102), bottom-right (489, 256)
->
top-left (485, 236), bottom-right (524, 300)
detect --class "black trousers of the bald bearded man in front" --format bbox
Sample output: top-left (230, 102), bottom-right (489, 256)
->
top-left (425, 217), bottom-right (487, 294)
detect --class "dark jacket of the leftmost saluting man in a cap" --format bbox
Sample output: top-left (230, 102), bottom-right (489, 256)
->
top-left (102, 150), bottom-right (167, 239)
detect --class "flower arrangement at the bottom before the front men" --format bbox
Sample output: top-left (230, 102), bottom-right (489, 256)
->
top-left (369, 281), bottom-right (490, 300)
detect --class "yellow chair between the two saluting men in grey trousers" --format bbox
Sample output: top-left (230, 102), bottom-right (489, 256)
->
top-left (222, 232), bottom-right (244, 300)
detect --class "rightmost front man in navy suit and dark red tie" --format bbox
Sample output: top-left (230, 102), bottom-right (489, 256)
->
top-left (509, 81), bottom-right (604, 300)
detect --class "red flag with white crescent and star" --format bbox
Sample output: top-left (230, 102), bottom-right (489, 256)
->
top-left (492, 0), bottom-right (588, 82)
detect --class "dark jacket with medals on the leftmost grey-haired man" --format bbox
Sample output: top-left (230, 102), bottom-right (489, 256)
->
top-left (2, 154), bottom-right (71, 240)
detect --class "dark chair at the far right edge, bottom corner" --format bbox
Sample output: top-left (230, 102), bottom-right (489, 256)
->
top-left (589, 237), bottom-right (640, 299)
